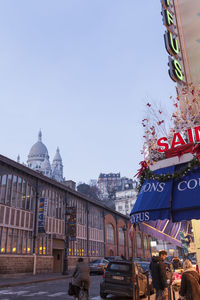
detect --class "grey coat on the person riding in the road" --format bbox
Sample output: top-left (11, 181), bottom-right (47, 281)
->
top-left (73, 262), bottom-right (90, 289)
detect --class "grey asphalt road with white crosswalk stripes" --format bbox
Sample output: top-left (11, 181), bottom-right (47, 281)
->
top-left (0, 275), bottom-right (178, 300)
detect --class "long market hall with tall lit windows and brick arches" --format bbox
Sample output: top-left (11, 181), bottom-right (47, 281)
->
top-left (0, 155), bottom-right (150, 273)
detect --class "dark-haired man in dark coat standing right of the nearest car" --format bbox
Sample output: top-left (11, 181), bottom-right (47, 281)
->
top-left (150, 250), bottom-right (168, 300)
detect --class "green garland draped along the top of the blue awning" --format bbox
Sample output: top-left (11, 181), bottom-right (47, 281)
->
top-left (138, 157), bottom-right (200, 193)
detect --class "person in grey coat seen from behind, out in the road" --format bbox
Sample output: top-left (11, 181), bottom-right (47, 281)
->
top-left (72, 257), bottom-right (90, 300)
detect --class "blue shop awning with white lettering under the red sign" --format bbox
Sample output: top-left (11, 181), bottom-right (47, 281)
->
top-left (131, 164), bottom-right (200, 223)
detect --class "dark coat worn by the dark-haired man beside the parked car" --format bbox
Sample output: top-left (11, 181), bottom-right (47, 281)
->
top-left (150, 256), bottom-right (168, 290)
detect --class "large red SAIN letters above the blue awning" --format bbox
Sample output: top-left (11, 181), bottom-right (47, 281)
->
top-left (157, 126), bottom-right (200, 152)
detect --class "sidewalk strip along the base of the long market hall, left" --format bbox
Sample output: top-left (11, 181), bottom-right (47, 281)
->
top-left (0, 273), bottom-right (72, 288)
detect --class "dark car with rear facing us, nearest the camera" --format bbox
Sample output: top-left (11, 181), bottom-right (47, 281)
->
top-left (100, 260), bottom-right (154, 298)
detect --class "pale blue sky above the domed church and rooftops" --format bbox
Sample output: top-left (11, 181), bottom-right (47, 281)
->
top-left (0, 0), bottom-right (175, 182)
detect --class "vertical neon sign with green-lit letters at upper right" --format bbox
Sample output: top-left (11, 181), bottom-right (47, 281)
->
top-left (161, 0), bottom-right (184, 83)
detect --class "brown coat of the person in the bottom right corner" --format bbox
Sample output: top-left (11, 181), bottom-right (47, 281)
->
top-left (179, 269), bottom-right (200, 300)
